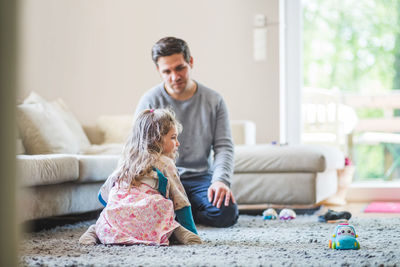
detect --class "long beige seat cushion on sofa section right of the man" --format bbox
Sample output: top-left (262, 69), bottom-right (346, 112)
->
top-left (235, 145), bottom-right (344, 173)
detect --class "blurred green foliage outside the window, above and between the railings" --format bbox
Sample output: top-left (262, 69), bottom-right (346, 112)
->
top-left (303, 0), bottom-right (400, 179)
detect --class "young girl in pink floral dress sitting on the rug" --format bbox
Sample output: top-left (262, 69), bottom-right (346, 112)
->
top-left (80, 109), bottom-right (201, 245)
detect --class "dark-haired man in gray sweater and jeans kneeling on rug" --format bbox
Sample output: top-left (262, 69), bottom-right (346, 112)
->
top-left (136, 37), bottom-right (238, 227)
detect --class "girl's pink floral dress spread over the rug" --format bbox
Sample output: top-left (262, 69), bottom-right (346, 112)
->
top-left (96, 159), bottom-right (187, 245)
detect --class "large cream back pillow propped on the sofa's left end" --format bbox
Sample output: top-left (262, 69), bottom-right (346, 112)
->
top-left (17, 93), bottom-right (90, 154)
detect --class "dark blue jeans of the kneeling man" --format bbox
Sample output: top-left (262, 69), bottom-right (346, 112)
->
top-left (181, 175), bottom-right (239, 227)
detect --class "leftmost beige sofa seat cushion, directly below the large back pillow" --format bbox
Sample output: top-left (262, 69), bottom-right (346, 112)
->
top-left (17, 154), bottom-right (79, 186)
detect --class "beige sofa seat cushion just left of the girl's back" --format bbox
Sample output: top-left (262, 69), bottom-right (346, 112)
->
top-left (76, 155), bottom-right (119, 183)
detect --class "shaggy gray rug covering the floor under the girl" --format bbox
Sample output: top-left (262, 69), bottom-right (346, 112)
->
top-left (20, 215), bottom-right (400, 266)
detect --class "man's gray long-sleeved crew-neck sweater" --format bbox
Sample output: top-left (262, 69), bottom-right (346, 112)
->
top-left (135, 82), bottom-right (234, 186)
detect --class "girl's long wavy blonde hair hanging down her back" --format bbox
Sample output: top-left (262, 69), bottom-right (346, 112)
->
top-left (111, 109), bottom-right (182, 185)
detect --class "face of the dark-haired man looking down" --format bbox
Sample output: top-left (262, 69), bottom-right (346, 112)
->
top-left (157, 53), bottom-right (193, 95)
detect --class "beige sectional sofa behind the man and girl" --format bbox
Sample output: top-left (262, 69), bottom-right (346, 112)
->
top-left (17, 93), bottom-right (344, 222)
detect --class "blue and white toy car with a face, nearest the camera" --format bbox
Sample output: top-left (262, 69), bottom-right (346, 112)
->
top-left (329, 223), bottom-right (360, 249)
